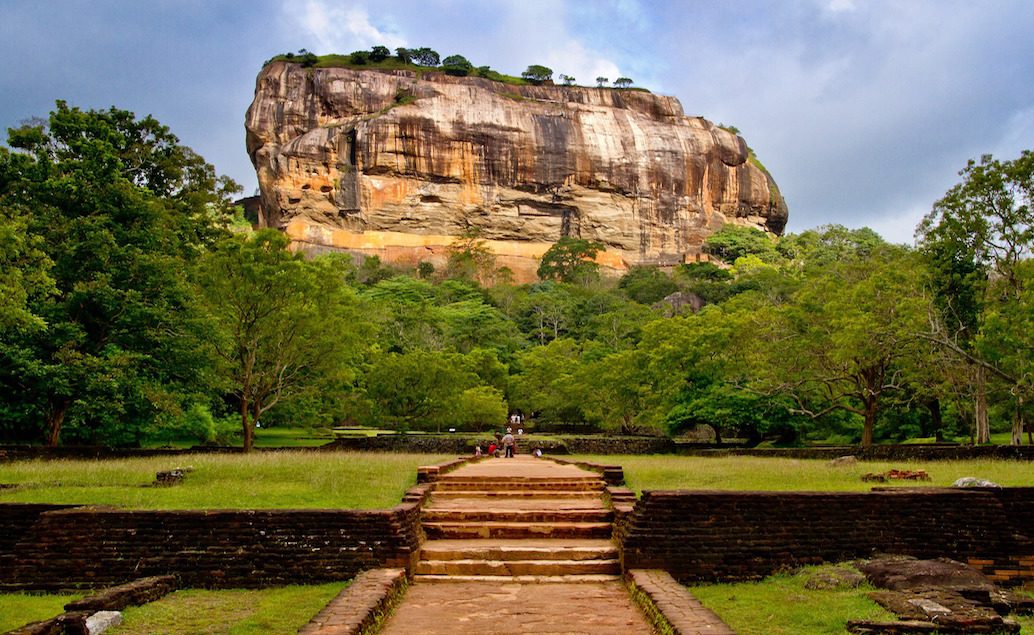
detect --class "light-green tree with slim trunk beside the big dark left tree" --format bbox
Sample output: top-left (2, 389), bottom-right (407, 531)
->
top-left (197, 230), bottom-right (365, 451)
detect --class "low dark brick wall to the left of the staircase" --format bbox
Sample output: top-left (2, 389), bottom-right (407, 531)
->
top-left (0, 502), bottom-right (422, 588)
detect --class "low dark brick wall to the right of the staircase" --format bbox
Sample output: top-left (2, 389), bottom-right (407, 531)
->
top-left (615, 488), bottom-right (1034, 582)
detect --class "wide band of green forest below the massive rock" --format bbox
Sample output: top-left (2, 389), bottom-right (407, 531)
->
top-left (0, 101), bottom-right (1034, 448)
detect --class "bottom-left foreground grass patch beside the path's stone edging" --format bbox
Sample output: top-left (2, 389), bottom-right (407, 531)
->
top-left (109, 582), bottom-right (344, 635)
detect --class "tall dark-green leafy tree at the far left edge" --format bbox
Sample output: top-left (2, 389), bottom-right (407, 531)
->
top-left (0, 101), bottom-right (239, 445)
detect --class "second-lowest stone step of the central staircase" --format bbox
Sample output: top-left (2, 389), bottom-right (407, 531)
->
top-left (420, 539), bottom-right (617, 562)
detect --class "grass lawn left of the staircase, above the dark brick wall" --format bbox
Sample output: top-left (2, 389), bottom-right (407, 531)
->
top-left (0, 450), bottom-right (452, 509)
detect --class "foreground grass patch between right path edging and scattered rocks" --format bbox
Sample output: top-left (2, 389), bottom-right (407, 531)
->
top-left (690, 567), bottom-right (895, 635)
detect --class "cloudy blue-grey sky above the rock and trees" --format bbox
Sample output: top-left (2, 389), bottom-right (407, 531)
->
top-left (0, 0), bottom-right (1034, 243)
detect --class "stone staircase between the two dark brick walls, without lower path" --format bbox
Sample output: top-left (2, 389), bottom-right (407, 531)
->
top-left (415, 456), bottom-right (620, 582)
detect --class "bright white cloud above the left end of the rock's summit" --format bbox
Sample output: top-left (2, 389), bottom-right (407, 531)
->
top-left (291, 0), bottom-right (406, 54)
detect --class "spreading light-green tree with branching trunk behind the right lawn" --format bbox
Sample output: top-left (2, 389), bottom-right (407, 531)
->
top-left (758, 245), bottom-right (929, 447)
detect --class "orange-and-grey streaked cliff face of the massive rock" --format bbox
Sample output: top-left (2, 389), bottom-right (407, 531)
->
top-left (246, 62), bottom-right (787, 280)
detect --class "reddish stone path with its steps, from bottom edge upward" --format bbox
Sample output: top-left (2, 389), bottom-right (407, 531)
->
top-left (381, 456), bottom-right (653, 635)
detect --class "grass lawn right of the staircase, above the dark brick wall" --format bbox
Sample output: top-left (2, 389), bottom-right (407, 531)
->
top-left (571, 455), bottom-right (1034, 492)
